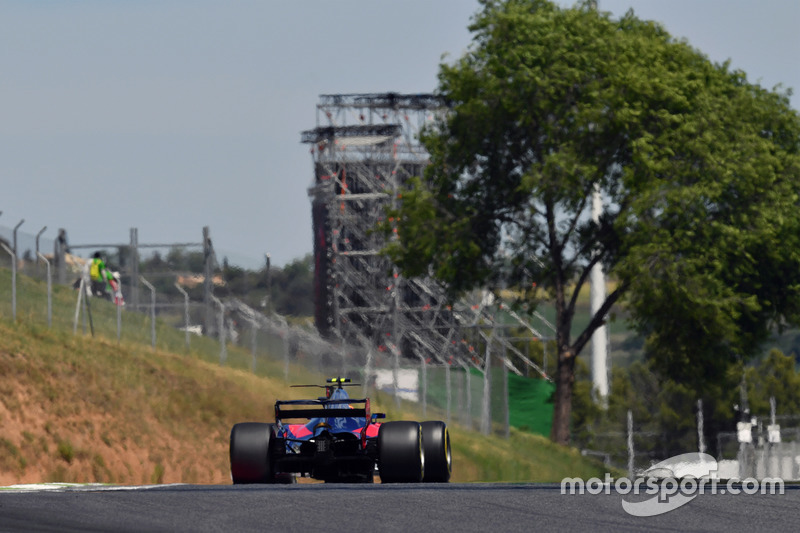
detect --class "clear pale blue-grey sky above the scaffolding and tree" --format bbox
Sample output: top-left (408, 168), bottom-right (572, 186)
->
top-left (0, 0), bottom-right (800, 269)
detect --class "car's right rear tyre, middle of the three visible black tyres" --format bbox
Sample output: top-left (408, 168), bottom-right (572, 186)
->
top-left (378, 421), bottom-right (425, 483)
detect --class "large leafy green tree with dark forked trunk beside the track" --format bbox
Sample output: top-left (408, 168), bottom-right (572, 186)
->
top-left (387, 0), bottom-right (800, 443)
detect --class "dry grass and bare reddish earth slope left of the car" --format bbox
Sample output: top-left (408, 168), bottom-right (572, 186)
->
top-left (0, 322), bottom-right (280, 484)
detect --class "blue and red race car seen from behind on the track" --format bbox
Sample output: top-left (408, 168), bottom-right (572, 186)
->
top-left (230, 378), bottom-right (452, 484)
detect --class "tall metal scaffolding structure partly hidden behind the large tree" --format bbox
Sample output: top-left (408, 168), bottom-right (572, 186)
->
top-left (301, 93), bottom-right (545, 375)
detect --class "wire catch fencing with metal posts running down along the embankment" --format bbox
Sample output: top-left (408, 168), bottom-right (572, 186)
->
top-left (0, 220), bottom-right (532, 436)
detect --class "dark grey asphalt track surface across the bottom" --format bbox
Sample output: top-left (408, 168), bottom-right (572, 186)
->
top-left (0, 484), bottom-right (800, 533)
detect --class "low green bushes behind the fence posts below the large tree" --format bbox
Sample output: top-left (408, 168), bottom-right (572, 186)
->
top-left (572, 349), bottom-right (800, 467)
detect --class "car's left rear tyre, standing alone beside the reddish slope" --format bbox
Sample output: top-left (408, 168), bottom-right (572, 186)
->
top-left (230, 422), bottom-right (275, 485)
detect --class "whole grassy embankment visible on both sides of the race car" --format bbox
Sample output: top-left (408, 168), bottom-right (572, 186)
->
top-left (0, 268), bottom-right (620, 484)
